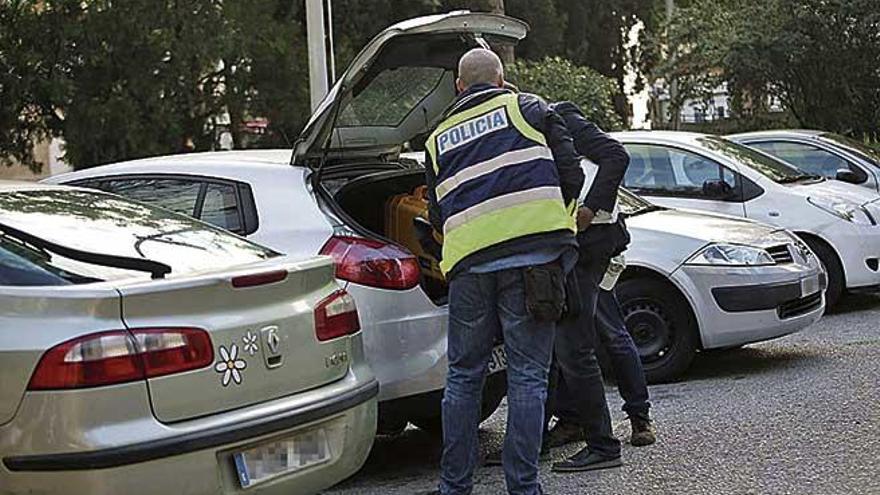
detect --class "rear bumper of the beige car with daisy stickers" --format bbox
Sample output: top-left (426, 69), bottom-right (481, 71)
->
top-left (0, 366), bottom-right (378, 495)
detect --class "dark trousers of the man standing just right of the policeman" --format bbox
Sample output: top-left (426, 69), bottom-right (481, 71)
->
top-left (547, 226), bottom-right (620, 456)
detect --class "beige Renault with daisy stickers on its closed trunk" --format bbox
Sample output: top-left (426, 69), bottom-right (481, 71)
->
top-left (0, 183), bottom-right (378, 495)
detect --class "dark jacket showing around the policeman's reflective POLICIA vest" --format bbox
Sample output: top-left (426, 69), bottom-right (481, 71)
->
top-left (425, 84), bottom-right (584, 279)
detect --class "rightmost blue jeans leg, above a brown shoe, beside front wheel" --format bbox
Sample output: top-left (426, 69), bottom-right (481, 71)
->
top-left (596, 290), bottom-right (651, 419)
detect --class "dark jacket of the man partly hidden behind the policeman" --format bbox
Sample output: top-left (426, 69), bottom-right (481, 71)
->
top-left (550, 101), bottom-right (629, 212)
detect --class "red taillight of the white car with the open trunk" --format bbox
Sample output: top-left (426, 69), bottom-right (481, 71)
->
top-left (321, 236), bottom-right (420, 289)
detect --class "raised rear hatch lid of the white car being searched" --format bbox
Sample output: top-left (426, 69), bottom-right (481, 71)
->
top-left (293, 11), bottom-right (528, 167)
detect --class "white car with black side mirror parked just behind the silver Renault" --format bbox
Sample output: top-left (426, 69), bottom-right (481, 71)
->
top-left (616, 131), bottom-right (880, 307)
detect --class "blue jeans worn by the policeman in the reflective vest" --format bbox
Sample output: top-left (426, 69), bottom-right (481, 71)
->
top-left (440, 268), bottom-right (556, 495)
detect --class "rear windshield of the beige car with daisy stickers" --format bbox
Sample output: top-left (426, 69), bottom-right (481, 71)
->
top-left (0, 189), bottom-right (278, 285)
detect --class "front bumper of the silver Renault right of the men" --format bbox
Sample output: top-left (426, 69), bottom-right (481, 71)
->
top-left (672, 265), bottom-right (825, 349)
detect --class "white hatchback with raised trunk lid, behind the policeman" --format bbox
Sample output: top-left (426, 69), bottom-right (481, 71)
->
top-left (51, 12), bottom-right (528, 432)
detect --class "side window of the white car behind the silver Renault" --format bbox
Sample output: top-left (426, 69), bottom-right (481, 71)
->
top-left (624, 144), bottom-right (736, 197)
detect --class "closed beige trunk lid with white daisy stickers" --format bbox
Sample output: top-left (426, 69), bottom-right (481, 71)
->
top-left (119, 257), bottom-right (351, 422)
